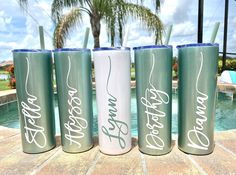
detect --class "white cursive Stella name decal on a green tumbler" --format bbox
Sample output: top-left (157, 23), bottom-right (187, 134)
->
top-left (20, 57), bottom-right (47, 148)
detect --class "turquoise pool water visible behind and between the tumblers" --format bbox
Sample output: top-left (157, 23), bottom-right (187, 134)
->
top-left (0, 90), bottom-right (236, 136)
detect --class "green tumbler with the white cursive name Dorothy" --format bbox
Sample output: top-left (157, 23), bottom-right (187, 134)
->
top-left (134, 45), bottom-right (172, 155)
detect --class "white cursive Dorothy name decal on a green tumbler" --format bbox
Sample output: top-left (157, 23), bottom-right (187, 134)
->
top-left (140, 54), bottom-right (169, 150)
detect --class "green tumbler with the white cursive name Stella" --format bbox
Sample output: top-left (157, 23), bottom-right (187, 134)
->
top-left (12, 49), bottom-right (56, 153)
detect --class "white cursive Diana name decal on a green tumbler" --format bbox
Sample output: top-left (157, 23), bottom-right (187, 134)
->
top-left (188, 52), bottom-right (210, 150)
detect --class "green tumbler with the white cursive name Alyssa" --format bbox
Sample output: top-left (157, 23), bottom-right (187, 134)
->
top-left (54, 48), bottom-right (93, 153)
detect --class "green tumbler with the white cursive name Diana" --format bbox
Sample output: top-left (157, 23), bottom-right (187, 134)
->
top-left (177, 43), bottom-right (219, 155)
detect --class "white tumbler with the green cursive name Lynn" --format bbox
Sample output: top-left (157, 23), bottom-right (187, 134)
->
top-left (93, 47), bottom-right (131, 155)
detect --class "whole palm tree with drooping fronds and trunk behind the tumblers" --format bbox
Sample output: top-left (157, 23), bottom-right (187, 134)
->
top-left (19, 0), bottom-right (163, 48)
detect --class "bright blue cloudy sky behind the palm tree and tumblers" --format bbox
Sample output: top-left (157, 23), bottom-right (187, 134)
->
top-left (0, 0), bottom-right (236, 62)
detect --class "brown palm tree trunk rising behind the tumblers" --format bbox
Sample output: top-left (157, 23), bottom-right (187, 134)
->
top-left (90, 14), bottom-right (101, 48)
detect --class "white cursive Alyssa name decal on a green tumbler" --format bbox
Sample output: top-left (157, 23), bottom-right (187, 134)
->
top-left (64, 57), bottom-right (88, 148)
